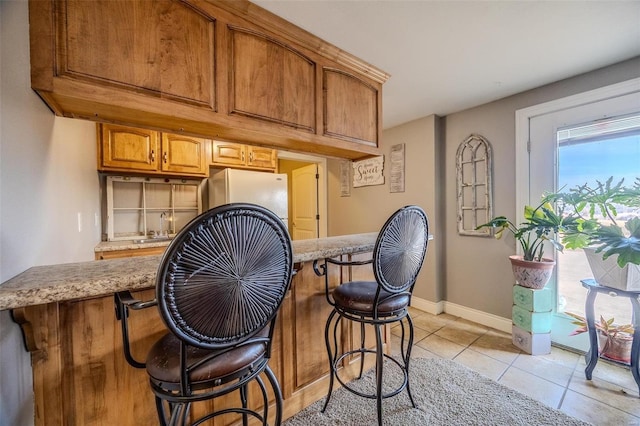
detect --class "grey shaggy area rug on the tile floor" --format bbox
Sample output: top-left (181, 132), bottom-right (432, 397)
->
top-left (284, 358), bottom-right (588, 426)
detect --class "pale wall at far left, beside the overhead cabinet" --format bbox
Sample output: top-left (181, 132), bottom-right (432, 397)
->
top-left (0, 1), bottom-right (100, 426)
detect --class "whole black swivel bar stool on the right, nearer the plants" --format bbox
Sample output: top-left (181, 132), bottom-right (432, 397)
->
top-left (314, 206), bottom-right (429, 425)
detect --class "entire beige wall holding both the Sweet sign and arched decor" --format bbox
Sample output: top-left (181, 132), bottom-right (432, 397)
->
top-left (328, 58), bottom-right (640, 321)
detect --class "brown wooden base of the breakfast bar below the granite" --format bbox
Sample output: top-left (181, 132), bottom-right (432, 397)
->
top-left (14, 254), bottom-right (391, 426)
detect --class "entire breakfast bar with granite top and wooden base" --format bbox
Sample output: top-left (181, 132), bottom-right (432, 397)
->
top-left (0, 233), bottom-right (382, 426)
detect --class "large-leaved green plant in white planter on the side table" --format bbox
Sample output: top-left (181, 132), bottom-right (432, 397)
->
top-left (543, 177), bottom-right (640, 290)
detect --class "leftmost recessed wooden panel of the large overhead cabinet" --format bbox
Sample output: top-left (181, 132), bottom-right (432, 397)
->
top-left (62, 0), bottom-right (215, 107)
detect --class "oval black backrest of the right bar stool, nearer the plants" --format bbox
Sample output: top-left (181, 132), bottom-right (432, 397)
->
top-left (373, 206), bottom-right (429, 293)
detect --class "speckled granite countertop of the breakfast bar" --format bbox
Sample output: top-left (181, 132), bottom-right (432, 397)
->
top-left (0, 232), bottom-right (378, 310)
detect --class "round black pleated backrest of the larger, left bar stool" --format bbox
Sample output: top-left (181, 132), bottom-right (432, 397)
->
top-left (156, 203), bottom-right (293, 350)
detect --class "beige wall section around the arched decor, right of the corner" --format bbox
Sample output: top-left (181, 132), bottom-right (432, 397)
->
top-left (440, 58), bottom-right (640, 318)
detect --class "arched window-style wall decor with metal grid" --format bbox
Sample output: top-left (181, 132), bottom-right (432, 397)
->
top-left (456, 135), bottom-right (493, 237)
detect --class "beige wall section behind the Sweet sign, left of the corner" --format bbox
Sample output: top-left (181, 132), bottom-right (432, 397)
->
top-left (328, 115), bottom-right (445, 301)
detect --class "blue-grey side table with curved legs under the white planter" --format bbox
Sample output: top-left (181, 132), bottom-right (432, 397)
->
top-left (580, 279), bottom-right (640, 392)
